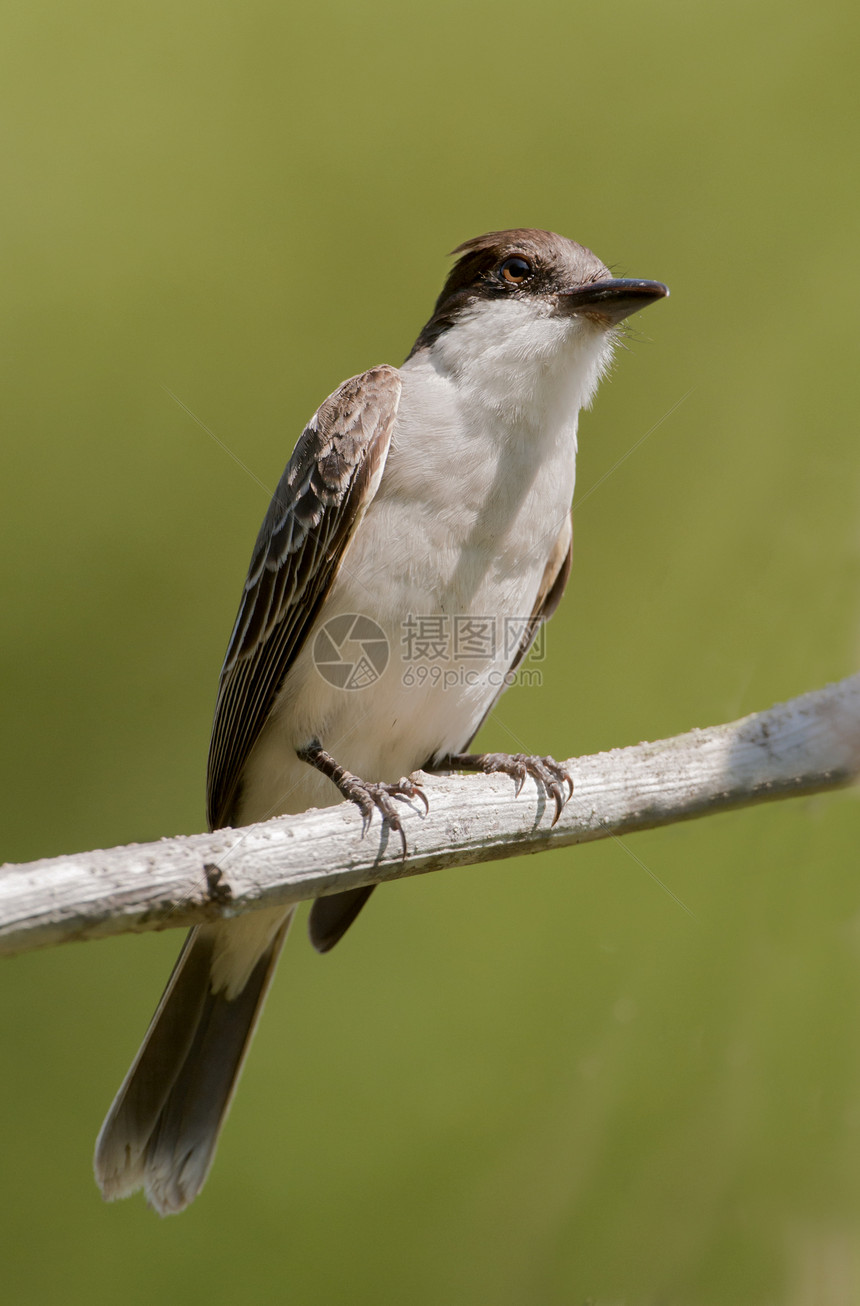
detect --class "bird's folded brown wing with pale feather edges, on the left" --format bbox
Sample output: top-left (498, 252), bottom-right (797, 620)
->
top-left (207, 366), bottom-right (400, 829)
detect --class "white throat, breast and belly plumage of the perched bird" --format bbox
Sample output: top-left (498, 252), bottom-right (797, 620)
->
top-left (232, 304), bottom-right (609, 821)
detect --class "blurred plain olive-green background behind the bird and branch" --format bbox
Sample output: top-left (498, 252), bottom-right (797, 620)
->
top-left (0, 0), bottom-right (860, 1306)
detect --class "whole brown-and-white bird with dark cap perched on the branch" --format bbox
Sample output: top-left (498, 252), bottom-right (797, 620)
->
top-left (94, 227), bottom-right (668, 1215)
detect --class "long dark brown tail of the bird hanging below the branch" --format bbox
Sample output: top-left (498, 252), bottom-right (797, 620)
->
top-left (94, 909), bottom-right (293, 1216)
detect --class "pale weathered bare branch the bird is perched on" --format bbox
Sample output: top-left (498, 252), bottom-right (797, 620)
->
top-left (0, 674), bottom-right (860, 955)
